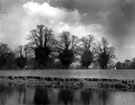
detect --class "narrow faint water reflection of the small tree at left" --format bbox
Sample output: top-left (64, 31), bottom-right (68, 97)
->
top-left (17, 86), bottom-right (26, 104)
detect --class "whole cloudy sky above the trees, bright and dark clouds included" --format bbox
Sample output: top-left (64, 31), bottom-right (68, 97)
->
top-left (0, 0), bottom-right (135, 61)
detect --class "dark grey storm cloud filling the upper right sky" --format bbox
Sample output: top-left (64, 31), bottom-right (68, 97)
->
top-left (48, 0), bottom-right (135, 40)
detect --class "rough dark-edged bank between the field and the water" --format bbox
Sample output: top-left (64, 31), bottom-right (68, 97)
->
top-left (0, 76), bottom-right (135, 91)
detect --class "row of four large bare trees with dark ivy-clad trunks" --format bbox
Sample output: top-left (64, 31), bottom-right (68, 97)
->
top-left (25, 25), bottom-right (115, 69)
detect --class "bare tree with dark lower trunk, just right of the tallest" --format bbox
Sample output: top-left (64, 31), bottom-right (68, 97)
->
top-left (58, 31), bottom-right (78, 69)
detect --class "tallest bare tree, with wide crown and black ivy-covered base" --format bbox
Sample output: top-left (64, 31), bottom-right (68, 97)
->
top-left (28, 25), bottom-right (56, 68)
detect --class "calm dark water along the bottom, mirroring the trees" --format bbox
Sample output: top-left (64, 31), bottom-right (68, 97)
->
top-left (0, 85), bottom-right (135, 105)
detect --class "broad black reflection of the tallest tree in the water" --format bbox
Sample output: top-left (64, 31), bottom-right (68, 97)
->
top-left (34, 87), bottom-right (50, 105)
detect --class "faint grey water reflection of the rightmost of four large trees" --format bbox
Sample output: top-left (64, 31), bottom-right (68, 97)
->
top-left (98, 90), bottom-right (110, 105)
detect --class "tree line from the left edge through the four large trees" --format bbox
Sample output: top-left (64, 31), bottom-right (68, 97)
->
top-left (0, 25), bottom-right (116, 69)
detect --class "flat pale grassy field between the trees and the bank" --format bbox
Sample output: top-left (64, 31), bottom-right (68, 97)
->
top-left (0, 70), bottom-right (135, 80)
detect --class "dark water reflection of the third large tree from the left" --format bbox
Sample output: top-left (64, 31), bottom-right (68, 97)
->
top-left (81, 89), bottom-right (92, 105)
